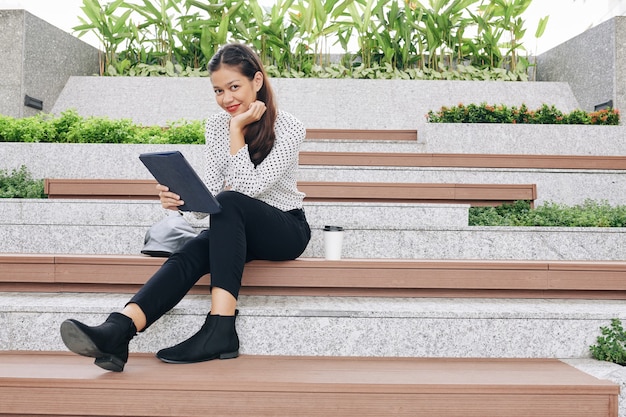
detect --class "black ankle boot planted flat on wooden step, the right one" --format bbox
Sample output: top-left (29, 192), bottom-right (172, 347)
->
top-left (156, 314), bottom-right (239, 363)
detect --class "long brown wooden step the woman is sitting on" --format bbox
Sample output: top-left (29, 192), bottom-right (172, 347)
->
top-left (0, 254), bottom-right (626, 299)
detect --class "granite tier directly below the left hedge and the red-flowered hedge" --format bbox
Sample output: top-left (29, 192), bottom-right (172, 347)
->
top-left (0, 129), bottom-right (626, 179)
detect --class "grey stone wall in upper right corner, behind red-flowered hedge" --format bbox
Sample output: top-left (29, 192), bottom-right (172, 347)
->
top-left (537, 16), bottom-right (626, 111)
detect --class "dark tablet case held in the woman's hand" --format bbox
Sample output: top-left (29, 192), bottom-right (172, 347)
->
top-left (139, 151), bottom-right (222, 214)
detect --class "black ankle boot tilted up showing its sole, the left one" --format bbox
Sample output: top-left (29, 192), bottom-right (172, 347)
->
top-left (61, 313), bottom-right (137, 372)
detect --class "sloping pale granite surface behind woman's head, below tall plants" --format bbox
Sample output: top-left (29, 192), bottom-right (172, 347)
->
top-left (52, 77), bottom-right (578, 129)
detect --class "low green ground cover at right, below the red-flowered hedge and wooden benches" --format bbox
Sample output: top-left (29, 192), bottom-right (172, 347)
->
top-left (469, 200), bottom-right (626, 227)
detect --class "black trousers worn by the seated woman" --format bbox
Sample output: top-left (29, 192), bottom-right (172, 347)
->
top-left (129, 191), bottom-right (311, 327)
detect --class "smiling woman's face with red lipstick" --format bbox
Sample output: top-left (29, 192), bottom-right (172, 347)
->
top-left (211, 65), bottom-right (263, 116)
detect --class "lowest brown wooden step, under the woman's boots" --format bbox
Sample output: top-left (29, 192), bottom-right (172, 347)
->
top-left (0, 352), bottom-right (619, 417)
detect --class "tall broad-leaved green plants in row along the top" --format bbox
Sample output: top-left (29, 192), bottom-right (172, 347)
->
top-left (74, 0), bottom-right (547, 80)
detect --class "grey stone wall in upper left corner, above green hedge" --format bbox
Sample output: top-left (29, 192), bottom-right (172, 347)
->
top-left (0, 10), bottom-right (99, 117)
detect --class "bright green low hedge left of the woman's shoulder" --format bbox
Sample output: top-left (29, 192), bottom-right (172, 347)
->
top-left (0, 110), bottom-right (204, 144)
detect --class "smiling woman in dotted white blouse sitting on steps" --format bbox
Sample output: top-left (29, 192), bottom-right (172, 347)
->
top-left (61, 44), bottom-right (311, 372)
